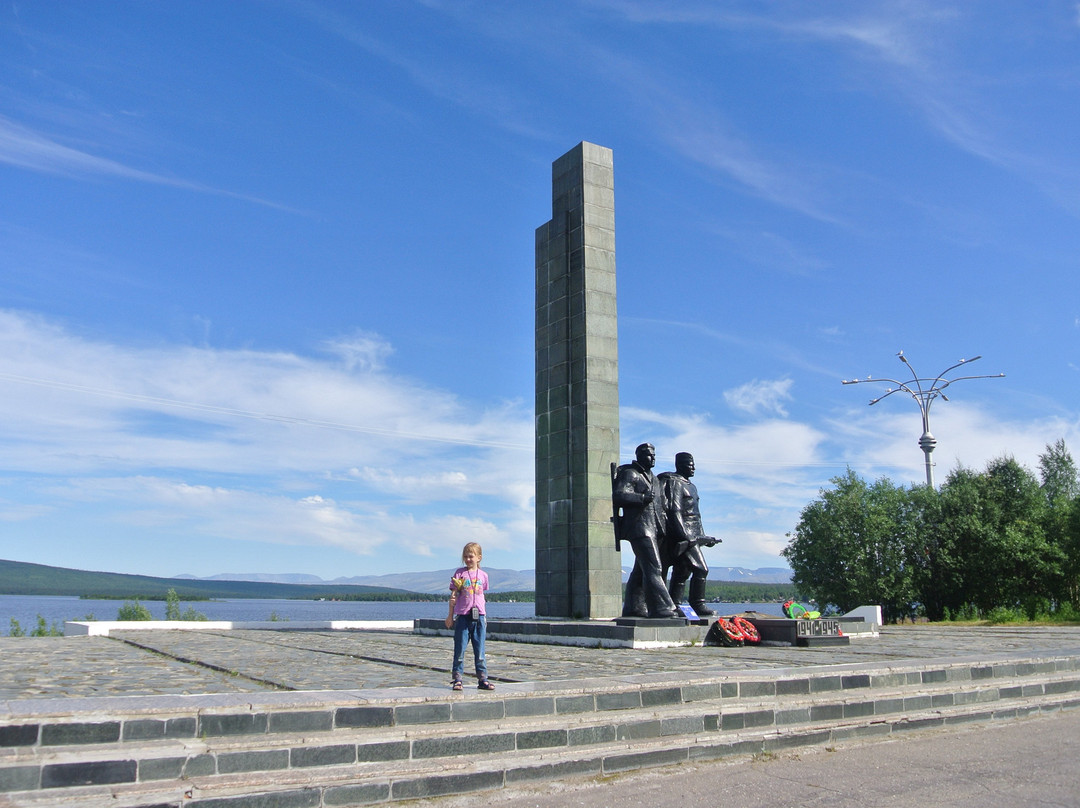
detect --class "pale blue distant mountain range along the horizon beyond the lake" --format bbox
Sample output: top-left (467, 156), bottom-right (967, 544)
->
top-left (176, 567), bottom-right (792, 593)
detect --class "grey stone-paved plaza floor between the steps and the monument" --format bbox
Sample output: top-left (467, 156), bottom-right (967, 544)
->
top-left (0, 625), bottom-right (1080, 700)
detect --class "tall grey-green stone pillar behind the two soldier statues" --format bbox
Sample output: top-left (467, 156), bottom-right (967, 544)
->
top-left (536, 143), bottom-right (622, 619)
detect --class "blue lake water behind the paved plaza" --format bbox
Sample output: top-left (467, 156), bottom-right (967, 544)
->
top-left (0, 595), bottom-right (781, 635)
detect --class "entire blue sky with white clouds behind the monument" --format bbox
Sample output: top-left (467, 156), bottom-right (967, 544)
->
top-left (0, 0), bottom-right (1080, 579)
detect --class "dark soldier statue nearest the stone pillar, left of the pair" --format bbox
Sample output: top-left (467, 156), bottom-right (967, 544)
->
top-left (611, 443), bottom-right (681, 618)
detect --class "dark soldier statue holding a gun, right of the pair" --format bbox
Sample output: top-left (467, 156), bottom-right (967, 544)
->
top-left (657, 452), bottom-right (720, 617)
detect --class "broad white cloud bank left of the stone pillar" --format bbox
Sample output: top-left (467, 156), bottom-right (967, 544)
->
top-left (0, 311), bottom-right (532, 557)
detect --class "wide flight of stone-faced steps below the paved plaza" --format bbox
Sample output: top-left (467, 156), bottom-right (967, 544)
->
top-left (0, 657), bottom-right (1080, 808)
